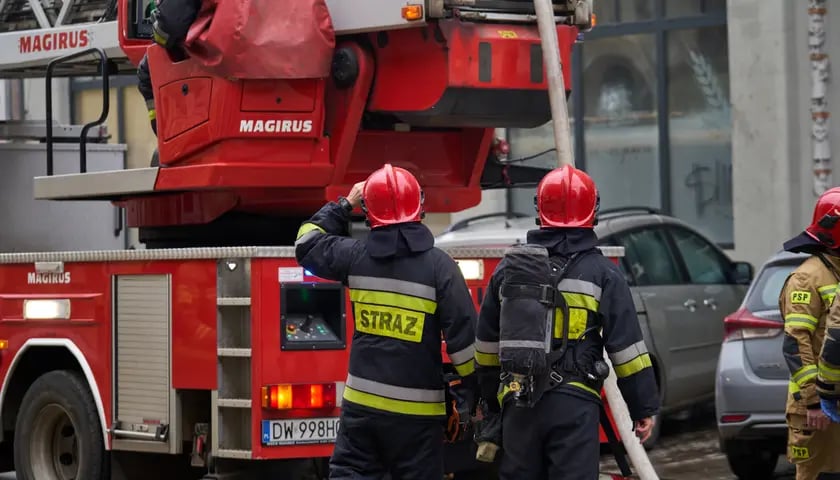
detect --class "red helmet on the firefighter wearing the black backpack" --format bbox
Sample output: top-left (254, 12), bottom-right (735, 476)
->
top-left (534, 166), bottom-right (600, 228)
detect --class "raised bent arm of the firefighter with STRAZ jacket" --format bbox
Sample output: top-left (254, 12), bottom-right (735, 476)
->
top-left (295, 183), bottom-right (364, 284)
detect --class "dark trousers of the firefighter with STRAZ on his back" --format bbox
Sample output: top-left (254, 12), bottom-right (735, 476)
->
top-left (330, 405), bottom-right (444, 480)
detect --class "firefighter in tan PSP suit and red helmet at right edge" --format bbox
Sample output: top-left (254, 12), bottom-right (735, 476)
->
top-left (779, 188), bottom-right (840, 480)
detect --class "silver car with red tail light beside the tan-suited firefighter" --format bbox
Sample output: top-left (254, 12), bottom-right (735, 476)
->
top-left (715, 252), bottom-right (808, 479)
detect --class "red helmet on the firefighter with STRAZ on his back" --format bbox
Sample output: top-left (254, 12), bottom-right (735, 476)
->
top-left (362, 163), bottom-right (423, 228)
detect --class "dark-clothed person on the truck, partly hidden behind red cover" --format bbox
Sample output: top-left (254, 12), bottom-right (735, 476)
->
top-left (137, 0), bottom-right (201, 135)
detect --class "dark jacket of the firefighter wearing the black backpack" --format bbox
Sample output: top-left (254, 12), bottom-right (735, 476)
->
top-left (475, 228), bottom-right (659, 420)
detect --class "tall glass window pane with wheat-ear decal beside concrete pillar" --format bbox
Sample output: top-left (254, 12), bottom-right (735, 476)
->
top-left (666, 25), bottom-right (733, 245)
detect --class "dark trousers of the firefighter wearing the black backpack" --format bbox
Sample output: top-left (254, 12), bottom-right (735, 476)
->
top-left (496, 390), bottom-right (600, 480)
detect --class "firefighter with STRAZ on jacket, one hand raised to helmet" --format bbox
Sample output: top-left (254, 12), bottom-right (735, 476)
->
top-left (295, 164), bottom-right (476, 480)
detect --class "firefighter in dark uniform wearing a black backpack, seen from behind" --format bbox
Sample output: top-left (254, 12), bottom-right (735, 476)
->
top-left (475, 166), bottom-right (659, 480)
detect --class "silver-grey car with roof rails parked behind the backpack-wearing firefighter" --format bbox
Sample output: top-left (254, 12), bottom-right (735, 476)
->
top-left (436, 208), bottom-right (753, 447)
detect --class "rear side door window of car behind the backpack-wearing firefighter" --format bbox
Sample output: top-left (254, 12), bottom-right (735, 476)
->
top-left (616, 228), bottom-right (682, 286)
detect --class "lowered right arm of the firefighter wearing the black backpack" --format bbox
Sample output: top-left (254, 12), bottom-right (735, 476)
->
top-left (598, 260), bottom-right (660, 422)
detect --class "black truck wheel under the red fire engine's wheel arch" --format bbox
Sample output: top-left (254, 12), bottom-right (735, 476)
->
top-left (14, 370), bottom-right (107, 480)
